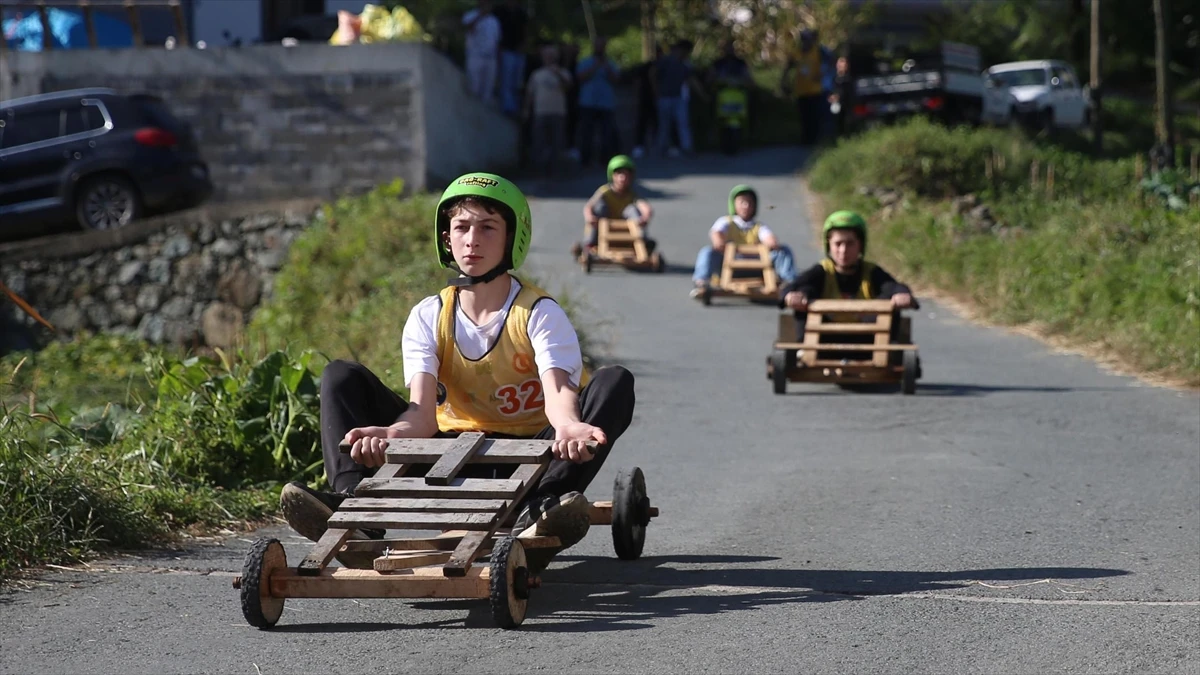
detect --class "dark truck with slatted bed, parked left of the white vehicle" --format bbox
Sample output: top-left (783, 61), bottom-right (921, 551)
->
top-left (850, 42), bottom-right (984, 127)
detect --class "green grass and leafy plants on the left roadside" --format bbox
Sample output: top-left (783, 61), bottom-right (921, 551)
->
top-left (0, 177), bottom-right (589, 580)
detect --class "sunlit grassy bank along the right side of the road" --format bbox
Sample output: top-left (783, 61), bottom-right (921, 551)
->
top-left (811, 120), bottom-right (1200, 387)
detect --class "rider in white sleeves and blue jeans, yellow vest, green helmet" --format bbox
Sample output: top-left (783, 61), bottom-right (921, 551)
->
top-left (691, 185), bottom-right (796, 298)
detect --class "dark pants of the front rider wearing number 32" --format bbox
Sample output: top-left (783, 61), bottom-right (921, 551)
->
top-left (320, 360), bottom-right (634, 498)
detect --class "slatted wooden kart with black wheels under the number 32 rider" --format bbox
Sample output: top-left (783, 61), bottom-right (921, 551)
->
top-left (233, 432), bottom-right (658, 628)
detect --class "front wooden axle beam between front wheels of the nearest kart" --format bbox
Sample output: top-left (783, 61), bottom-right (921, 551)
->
top-left (270, 566), bottom-right (490, 598)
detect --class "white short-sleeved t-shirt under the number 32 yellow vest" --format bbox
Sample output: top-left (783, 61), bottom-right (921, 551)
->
top-left (401, 279), bottom-right (583, 387)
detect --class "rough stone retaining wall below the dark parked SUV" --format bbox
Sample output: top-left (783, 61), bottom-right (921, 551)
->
top-left (0, 201), bottom-right (320, 347)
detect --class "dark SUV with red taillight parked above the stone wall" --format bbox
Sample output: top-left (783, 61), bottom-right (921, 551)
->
top-left (0, 89), bottom-right (212, 239)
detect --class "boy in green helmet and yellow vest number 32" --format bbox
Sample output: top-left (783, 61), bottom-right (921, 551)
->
top-left (280, 173), bottom-right (634, 572)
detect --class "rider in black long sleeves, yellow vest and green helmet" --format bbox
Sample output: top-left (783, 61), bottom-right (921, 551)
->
top-left (779, 210), bottom-right (919, 340)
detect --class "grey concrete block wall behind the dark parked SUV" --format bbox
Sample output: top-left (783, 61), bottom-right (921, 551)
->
top-left (0, 43), bottom-right (518, 201)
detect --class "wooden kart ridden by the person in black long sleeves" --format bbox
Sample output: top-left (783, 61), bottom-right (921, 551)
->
top-left (767, 300), bottom-right (920, 394)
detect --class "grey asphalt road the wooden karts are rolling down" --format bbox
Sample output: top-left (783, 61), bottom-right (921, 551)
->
top-left (0, 144), bottom-right (1200, 674)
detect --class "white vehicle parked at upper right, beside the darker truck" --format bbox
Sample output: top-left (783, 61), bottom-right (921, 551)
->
top-left (982, 60), bottom-right (1092, 131)
